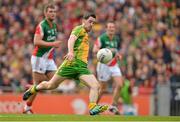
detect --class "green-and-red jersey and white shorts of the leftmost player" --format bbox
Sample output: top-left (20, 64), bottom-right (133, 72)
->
top-left (31, 19), bottom-right (57, 73)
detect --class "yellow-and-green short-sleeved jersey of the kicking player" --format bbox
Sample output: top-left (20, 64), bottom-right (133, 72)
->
top-left (71, 25), bottom-right (89, 63)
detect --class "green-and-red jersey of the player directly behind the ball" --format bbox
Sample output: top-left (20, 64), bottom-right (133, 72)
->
top-left (95, 33), bottom-right (120, 65)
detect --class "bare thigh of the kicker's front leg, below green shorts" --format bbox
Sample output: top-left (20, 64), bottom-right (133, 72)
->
top-left (79, 74), bottom-right (100, 88)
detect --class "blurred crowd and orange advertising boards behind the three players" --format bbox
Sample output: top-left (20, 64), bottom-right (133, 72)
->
top-left (0, 0), bottom-right (180, 116)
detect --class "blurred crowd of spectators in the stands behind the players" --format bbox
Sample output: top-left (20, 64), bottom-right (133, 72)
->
top-left (0, 0), bottom-right (180, 95)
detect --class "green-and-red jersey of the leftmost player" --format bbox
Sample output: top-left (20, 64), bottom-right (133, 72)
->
top-left (33, 19), bottom-right (57, 59)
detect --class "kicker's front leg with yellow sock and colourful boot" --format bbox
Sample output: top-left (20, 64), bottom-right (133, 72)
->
top-left (79, 74), bottom-right (108, 115)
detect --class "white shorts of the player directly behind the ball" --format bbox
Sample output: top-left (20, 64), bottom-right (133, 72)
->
top-left (97, 62), bottom-right (122, 82)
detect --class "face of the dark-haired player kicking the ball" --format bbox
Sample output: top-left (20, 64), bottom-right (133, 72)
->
top-left (83, 17), bottom-right (96, 32)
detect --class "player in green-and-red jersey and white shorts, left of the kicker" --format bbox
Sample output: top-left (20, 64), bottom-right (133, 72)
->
top-left (23, 4), bottom-right (61, 114)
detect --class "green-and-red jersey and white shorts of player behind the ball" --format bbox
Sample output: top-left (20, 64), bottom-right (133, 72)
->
top-left (95, 33), bottom-right (122, 82)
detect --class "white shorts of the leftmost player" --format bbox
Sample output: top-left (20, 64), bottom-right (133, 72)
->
top-left (31, 56), bottom-right (57, 74)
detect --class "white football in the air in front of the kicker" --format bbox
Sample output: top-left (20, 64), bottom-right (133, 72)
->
top-left (97, 48), bottom-right (113, 64)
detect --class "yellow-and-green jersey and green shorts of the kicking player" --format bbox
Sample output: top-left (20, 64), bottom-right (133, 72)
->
top-left (56, 25), bottom-right (91, 81)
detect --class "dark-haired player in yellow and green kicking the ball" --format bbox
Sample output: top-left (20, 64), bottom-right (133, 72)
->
top-left (23, 13), bottom-right (108, 115)
